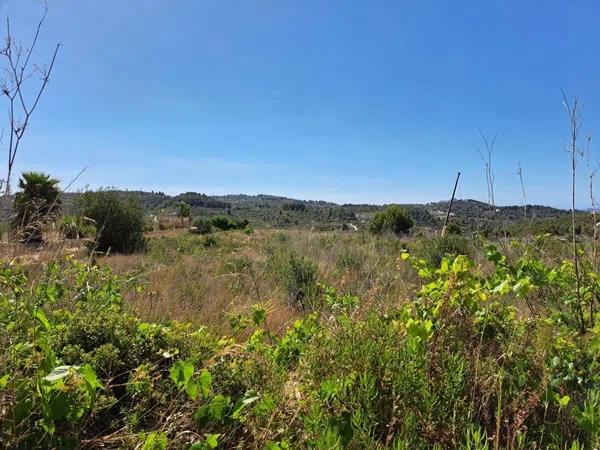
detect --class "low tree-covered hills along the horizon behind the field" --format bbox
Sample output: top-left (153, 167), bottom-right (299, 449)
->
top-left (3, 191), bottom-right (572, 234)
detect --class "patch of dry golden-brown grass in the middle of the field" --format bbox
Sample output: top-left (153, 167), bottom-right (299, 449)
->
top-left (100, 230), bottom-right (417, 331)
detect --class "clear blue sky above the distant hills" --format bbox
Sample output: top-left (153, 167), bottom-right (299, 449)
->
top-left (0, 0), bottom-right (600, 207)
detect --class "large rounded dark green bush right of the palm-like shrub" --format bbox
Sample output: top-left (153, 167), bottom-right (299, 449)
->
top-left (77, 190), bottom-right (146, 253)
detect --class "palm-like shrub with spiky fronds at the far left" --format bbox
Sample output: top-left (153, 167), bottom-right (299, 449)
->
top-left (13, 172), bottom-right (61, 242)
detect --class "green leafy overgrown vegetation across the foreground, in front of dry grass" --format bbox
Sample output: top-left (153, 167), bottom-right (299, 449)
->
top-left (0, 230), bottom-right (600, 449)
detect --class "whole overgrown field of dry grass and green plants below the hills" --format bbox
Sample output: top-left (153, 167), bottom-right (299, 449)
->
top-left (0, 221), bottom-right (600, 449)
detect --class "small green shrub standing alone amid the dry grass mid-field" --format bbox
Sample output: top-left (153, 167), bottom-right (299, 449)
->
top-left (280, 253), bottom-right (318, 309)
